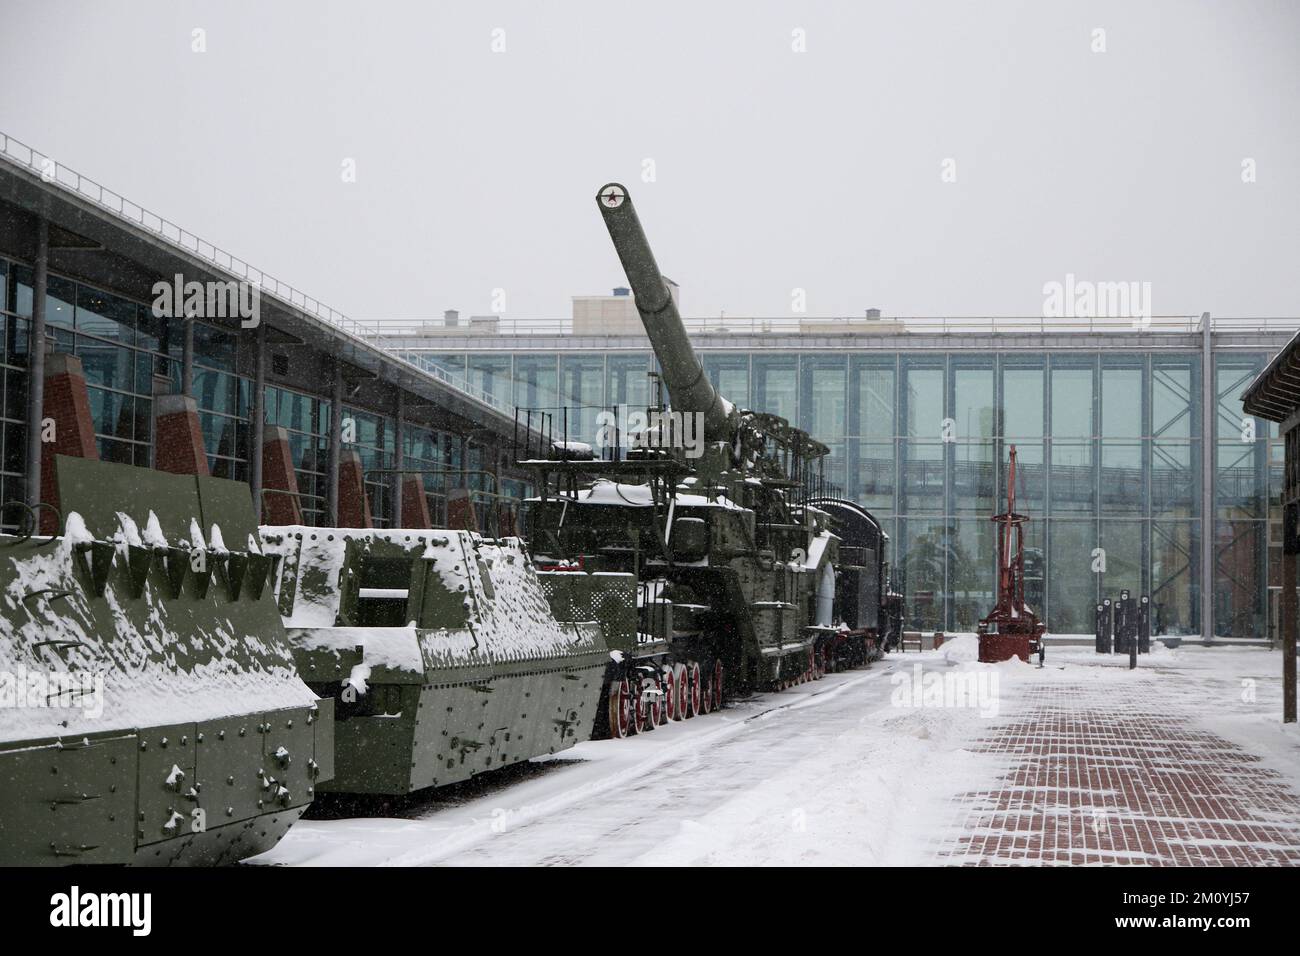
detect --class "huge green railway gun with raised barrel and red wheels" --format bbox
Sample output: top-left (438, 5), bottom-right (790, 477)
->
top-left (516, 183), bottom-right (881, 736)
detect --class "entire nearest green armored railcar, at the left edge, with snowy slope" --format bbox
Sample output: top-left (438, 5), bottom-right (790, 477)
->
top-left (0, 457), bottom-right (334, 866)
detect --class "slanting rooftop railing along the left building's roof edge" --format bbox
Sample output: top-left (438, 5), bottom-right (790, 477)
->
top-left (0, 131), bottom-right (514, 415)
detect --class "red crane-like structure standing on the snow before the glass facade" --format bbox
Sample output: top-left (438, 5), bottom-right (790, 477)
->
top-left (979, 445), bottom-right (1047, 663)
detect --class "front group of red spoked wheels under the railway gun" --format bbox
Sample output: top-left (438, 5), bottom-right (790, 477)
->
top-left (608, 661), bottom-right (723, 737)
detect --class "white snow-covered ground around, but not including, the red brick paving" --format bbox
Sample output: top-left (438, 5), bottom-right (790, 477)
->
top-left (245, 637), bottom-right (1300, 866)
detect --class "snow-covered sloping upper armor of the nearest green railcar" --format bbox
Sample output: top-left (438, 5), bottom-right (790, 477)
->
top-left (0, 511), bottom-right (316, 741)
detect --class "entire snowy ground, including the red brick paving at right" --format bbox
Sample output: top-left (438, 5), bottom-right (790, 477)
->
top-left (256, 639), bottom-right (1300, 865)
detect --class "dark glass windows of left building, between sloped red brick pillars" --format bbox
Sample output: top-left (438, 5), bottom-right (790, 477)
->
top-left (0, 256), bottom-right (491, 528)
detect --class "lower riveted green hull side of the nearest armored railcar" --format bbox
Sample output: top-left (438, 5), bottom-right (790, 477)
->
top-left (0, 700), bottom-right (334, 866)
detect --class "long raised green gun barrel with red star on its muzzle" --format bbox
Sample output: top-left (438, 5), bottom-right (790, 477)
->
top-left (595, 182), bottom-right (737, 441)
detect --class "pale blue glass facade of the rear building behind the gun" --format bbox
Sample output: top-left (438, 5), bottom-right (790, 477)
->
top-left (403, 333), bottom-right (1284, 637)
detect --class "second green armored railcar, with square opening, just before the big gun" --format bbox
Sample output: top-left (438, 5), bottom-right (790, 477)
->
top-left (261, 527), bottom-right (624, 795)
